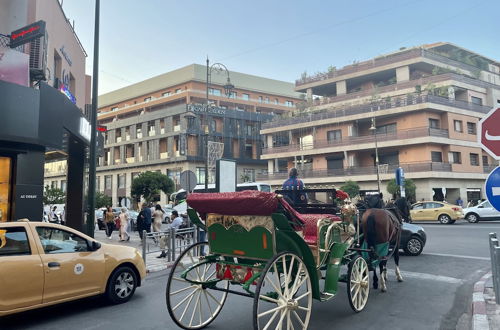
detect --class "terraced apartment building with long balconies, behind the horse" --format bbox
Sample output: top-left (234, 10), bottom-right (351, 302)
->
top-left (257, 42), bottom-right (500, 202)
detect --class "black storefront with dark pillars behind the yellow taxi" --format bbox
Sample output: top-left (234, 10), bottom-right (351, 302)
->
top-left (0, 81), bottom-right (90, 229)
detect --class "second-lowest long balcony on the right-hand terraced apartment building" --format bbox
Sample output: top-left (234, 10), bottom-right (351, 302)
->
top-left (262, 127), bottom-right (449, 155)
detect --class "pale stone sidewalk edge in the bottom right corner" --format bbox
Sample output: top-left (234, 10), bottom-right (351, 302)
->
top-left (472, 272), bottom-right (500, 330)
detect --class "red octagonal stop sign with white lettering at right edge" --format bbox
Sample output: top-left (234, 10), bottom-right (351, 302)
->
top-left (477, 108), bottom-right (500, 160)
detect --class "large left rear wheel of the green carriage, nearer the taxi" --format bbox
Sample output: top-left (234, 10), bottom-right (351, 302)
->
top-left (166, 242), bottom-right (229, 329)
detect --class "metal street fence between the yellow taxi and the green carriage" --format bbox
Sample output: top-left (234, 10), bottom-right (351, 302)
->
top-left (142, 226), bottom-right (199, 263)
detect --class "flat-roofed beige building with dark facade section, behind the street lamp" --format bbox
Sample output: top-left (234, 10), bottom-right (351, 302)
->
top-left (43, 64), bottom-right (300, 205)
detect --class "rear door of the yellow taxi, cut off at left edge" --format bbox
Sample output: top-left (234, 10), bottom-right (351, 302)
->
top-left (0, 223), bottom-right (44, 314)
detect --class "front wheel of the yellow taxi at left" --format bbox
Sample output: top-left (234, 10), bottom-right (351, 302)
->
top-left (106, 266), bottom-right (137, 304)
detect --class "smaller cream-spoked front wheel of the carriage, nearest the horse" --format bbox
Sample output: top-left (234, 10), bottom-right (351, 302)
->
top-left (347, 256), bottom-right (370, 313)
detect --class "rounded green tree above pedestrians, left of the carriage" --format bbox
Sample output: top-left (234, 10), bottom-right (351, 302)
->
top-left (131, 171), bottom-right (175, 203)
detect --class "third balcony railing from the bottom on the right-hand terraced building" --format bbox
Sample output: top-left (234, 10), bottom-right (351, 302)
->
top-left (262, 94), bottom-right (491, 129)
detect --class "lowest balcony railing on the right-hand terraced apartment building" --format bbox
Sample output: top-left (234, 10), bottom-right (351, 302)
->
top-left (257, 162), bottom-right (451, 181)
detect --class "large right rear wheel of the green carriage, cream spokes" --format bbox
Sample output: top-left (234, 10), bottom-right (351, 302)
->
top-left (253, 252), bottom-right (312, 330)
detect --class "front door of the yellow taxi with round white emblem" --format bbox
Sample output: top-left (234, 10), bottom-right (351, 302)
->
top-left (36, 225), bottom-right (104, 303)
